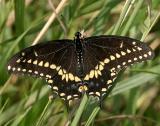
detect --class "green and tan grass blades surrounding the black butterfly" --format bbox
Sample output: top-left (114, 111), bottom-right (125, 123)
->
top-left (0, 0), bottom-right (160, 126)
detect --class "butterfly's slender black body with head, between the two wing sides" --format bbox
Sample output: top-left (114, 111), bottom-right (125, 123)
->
top-left (74, 32), bottom-right (84, 78)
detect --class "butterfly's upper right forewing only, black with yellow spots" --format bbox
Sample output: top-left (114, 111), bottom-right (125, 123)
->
top-left (85, 36), bottom-right (154, 69)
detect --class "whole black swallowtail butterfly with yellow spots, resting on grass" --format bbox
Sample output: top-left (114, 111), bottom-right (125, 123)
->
top-left (8, 32), bottom-right (154, 104)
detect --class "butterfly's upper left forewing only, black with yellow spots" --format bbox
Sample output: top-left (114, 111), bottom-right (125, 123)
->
top-left (8, 40), bottom-right (72, 77)
